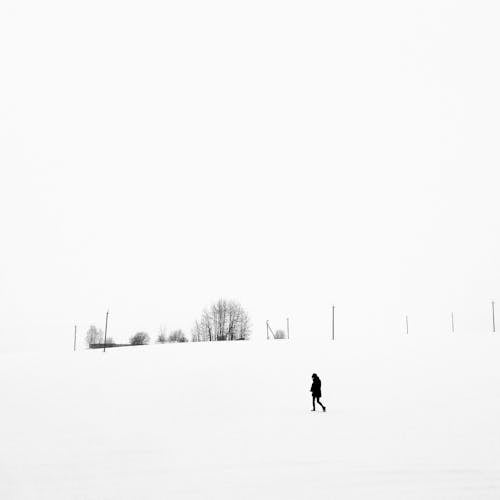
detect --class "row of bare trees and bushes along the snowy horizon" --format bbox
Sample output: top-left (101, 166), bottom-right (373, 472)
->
top-left (85, 299), bottom-right (251, 347)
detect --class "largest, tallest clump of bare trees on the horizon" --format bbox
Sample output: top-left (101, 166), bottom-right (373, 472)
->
top-left (192, 299), bottom-right (250, 342)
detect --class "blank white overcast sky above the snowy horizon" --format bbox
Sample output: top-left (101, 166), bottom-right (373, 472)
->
top-left (0, 0), bottom-right (500, 349)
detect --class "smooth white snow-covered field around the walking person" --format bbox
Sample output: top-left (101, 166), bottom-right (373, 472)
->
top-left (0, 335), bottom-right (500, 500)
